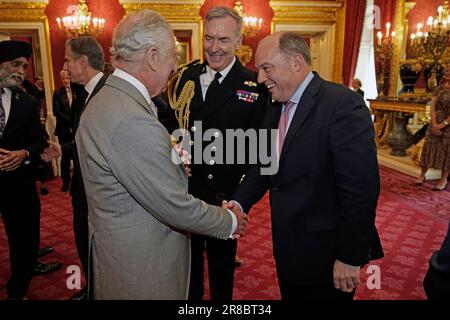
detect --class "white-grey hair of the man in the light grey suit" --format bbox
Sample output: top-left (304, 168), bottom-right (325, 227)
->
top-left (110, 10), bottom-right (174, 62)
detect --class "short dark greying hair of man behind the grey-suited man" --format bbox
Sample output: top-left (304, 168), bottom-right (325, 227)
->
top-left (66, 36), bottom-right (105, 71)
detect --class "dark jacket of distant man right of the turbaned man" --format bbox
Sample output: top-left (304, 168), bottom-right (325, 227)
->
top-left (53, 87), bottom-right (76, 144)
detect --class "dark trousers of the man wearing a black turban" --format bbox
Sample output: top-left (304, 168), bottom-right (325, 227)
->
top-left (0, 178), bottom-right (40, 298)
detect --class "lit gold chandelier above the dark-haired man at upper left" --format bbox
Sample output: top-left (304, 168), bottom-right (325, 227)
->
top-left (56, 0), bottom-right (106, 38)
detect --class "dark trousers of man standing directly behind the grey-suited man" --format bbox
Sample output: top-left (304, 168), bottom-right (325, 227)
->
top-left (72, 192), bottom-right (89, 283)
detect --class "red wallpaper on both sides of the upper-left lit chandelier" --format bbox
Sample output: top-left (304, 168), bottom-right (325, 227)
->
top-left (45, 0), bottom-right (125, 88)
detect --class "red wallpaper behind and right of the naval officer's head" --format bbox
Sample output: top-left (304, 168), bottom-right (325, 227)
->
top-left (200, 0), bottom-right (273, 70)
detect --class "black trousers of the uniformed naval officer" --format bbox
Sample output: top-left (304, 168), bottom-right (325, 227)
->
top-left (188, 234), bottom-right (237, 301)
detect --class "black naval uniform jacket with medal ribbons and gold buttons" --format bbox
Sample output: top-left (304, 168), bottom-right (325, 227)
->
top-left (162, 59), bottom-right (267, 204)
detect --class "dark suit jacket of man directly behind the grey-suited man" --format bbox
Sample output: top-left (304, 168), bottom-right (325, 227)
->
top-left (70, 75), bottom-right (108, 201)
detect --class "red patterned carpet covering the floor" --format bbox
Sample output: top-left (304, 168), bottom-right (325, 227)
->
top-left (0, 168), bottom-right (450, 300)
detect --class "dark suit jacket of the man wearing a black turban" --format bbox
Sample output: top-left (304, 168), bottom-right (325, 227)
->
top-left (0, 89), bottom-right (47, 183)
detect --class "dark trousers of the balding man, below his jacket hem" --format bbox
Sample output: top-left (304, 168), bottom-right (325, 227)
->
top-left (277, 269), bottom-right (356, 301)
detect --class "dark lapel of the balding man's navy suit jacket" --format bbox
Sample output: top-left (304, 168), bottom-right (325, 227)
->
top-left (280, 73), bottom-right (323, 164)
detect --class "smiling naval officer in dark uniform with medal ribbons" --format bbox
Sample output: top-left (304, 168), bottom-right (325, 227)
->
top-left (162, 7), bottom-right (267, 300)
